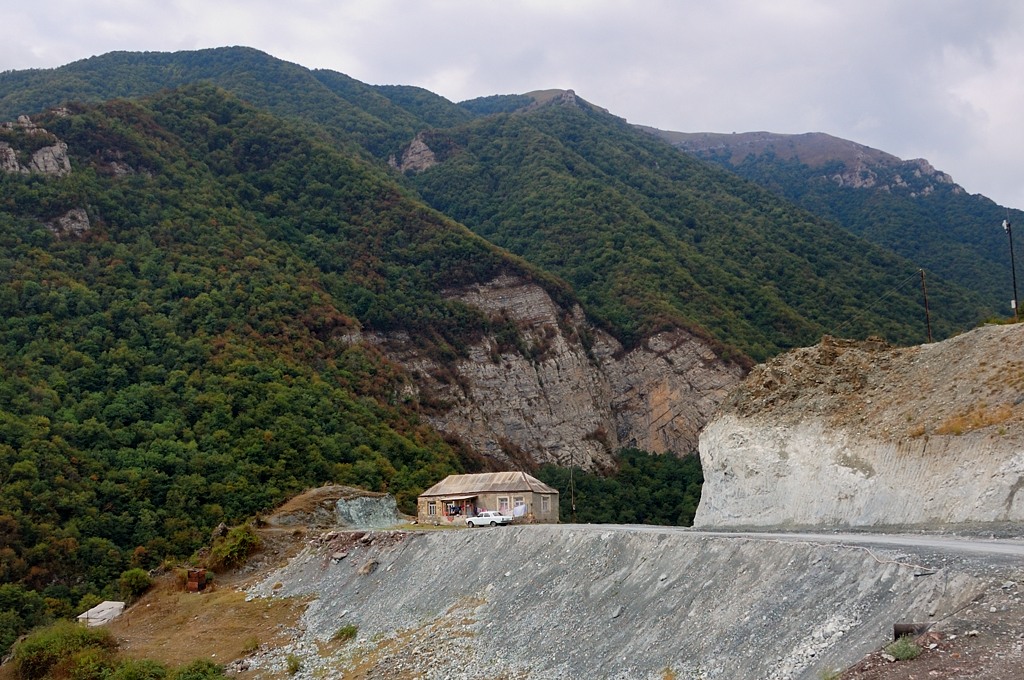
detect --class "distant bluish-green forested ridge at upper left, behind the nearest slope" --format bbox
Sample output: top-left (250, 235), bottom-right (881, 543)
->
top-left (0, 47), bottom-right (468, 157)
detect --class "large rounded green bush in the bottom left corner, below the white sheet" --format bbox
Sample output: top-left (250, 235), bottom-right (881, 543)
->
top-left (12, 621), bottom-right (117, 680)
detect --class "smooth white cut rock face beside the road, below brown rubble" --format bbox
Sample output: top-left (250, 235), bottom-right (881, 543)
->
top-left (694, 415), bottom-right (1024, 527)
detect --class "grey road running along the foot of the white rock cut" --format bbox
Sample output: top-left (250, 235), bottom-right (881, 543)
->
top-left (572, 524), bottom-right (1024, 566)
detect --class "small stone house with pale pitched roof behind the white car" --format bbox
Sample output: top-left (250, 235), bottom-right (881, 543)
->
top-left (417, 472), bottom-right (558, 524)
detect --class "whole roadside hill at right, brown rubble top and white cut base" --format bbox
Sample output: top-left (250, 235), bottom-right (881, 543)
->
top-left (694, 325), bottom-right (1024, 526)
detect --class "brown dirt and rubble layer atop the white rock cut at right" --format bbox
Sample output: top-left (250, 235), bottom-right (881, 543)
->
top-left (722, 325), bottom-right (1024, 445)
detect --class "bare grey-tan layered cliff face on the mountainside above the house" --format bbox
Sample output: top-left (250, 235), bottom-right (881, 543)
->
top-left (376, 277), bottom-right (742, 468)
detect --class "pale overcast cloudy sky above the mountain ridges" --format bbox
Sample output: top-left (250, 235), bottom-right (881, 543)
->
top-left (6, 0), bottom-right (1024, 209)
